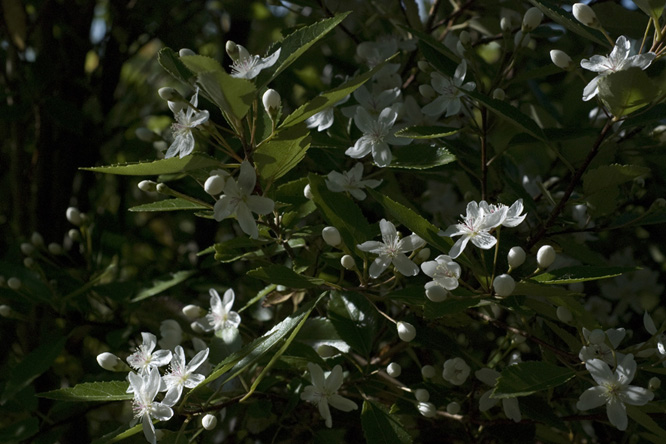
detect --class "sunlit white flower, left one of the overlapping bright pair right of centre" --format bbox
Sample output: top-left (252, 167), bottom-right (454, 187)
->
top-left (439, 201), bottom-right (508, 259)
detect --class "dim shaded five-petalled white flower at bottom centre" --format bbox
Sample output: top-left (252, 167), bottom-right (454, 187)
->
top-left (301, 362), bottom-right (358, 428)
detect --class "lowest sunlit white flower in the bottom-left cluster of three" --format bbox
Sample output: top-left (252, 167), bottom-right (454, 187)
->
top-left (127, 368), bottom-right (173, 444)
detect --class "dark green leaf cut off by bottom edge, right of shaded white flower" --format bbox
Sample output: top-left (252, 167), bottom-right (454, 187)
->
top-left (361, 400), bottom-right (412, 444)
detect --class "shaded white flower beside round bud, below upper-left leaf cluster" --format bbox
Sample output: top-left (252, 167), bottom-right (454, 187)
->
top-left (213, 160), bottom-right (275, 239)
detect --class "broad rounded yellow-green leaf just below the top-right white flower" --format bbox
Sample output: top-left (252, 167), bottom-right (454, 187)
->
top-left (597, 66), bottom-right (661, 117)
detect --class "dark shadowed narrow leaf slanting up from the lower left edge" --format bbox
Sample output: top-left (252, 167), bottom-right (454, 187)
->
top-left (0, 335), bottom-right (67, 405)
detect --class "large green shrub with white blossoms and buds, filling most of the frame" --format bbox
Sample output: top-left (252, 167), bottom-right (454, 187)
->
top-left (1, 0), bottom-right (666, 443)
